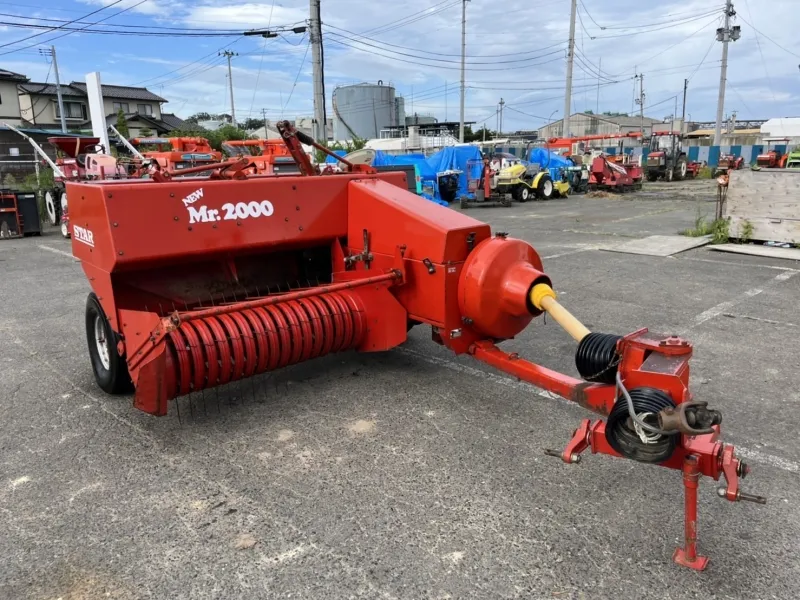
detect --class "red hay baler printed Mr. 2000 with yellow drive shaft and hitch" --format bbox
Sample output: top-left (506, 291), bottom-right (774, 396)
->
top-left (68, 123), bottom-right (765, 569)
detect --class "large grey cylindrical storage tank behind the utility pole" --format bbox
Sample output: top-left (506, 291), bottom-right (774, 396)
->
top-left (333, 81), bottom-right (397, 140)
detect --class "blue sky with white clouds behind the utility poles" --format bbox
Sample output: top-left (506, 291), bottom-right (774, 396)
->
top-left (0, 0), bottom-right (800, 131)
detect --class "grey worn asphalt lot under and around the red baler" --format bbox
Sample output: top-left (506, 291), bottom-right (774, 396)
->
top-left (0, 182), bottom-right (800, 600)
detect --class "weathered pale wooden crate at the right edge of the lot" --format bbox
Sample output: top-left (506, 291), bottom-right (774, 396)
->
top-left (724, 169), bottom-right (800, 244)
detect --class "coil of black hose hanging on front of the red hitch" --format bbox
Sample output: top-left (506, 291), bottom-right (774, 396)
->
top-left (606, 387), bottom-right (680, 464)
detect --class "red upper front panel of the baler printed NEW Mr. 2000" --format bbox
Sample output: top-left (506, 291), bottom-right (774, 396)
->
top-left (70, 177), bottom-right (356, 271)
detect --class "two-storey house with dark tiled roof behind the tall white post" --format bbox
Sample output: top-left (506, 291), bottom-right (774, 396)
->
top-left (16, 78), bottom-right (186, 137)
